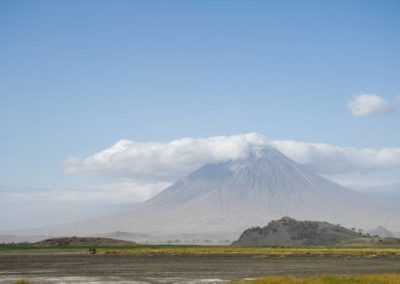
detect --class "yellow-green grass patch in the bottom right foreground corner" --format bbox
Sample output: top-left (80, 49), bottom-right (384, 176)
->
top-left (233, 274), bottom-right (400, 284)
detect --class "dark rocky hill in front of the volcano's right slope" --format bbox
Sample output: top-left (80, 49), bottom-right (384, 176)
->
top-left (232, 217), bottom-right (367, 246)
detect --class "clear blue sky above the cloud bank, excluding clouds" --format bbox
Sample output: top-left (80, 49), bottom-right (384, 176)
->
top-left (0, 0), bottom-right (400, 188)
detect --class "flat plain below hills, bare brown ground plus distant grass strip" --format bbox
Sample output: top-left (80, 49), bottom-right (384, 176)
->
top-left (0, 246), bottom-right (400, 283)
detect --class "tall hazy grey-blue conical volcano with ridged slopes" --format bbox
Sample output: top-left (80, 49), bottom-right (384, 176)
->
top-left (13, 147), bottom-right (400, 243)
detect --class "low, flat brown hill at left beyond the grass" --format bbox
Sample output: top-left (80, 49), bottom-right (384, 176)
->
top-left (34, 237), bottom-right (136, 247)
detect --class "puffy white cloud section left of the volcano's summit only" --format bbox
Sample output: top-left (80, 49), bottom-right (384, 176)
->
top-left (65, 133), bottom-right (267, 182)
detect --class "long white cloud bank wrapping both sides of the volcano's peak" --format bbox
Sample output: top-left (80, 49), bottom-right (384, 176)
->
top-left (65, 133), bottom-right (400, 183)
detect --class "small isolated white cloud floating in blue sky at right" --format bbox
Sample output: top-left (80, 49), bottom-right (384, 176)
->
top-left (347, 94), bottom-right (394, 117)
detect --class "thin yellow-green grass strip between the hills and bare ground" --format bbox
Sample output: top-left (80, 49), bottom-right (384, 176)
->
top-left (0, 245), bottom-right (400, 258)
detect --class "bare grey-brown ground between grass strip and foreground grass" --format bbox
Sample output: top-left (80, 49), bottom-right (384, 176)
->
top-left (0, 253), bottom-right (400, 283)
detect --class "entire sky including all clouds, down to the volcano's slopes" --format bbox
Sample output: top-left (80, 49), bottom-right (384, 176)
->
top-left (0, 0), bottom-right (400, 231)
